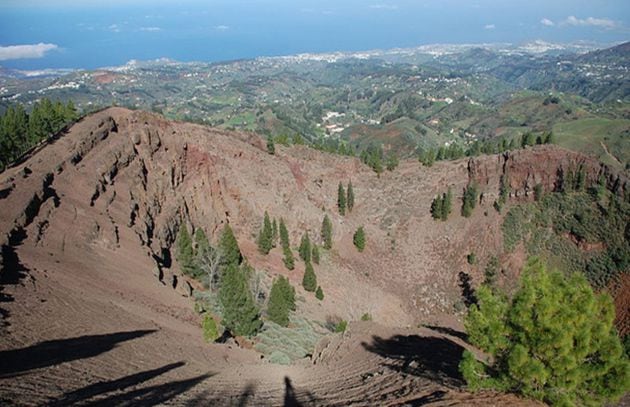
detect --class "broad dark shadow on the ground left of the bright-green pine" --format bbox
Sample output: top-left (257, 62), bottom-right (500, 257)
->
top-left (362, 335), bottom-right (464, 386)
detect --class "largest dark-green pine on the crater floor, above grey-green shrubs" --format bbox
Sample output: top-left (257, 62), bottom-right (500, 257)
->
top-left (219, 263), bottom-right (262, 336)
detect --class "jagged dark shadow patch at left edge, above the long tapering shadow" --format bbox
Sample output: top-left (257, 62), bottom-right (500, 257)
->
top-left (0, 228), bottom-right (28, 327)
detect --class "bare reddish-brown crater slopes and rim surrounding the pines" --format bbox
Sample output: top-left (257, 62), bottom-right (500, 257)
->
top-left (0, 108), bottom-right (628, 406)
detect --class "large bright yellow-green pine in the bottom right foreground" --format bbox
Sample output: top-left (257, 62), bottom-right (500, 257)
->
top-left (460, 259), bottom-right (630, 406)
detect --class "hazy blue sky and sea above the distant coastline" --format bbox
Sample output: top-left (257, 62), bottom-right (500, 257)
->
top-left (0, 0), bottom-right (630, 69)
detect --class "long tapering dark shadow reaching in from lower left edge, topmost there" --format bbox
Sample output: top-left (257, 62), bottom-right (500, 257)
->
top-left (0, 329), bottom-right (156, 378)
